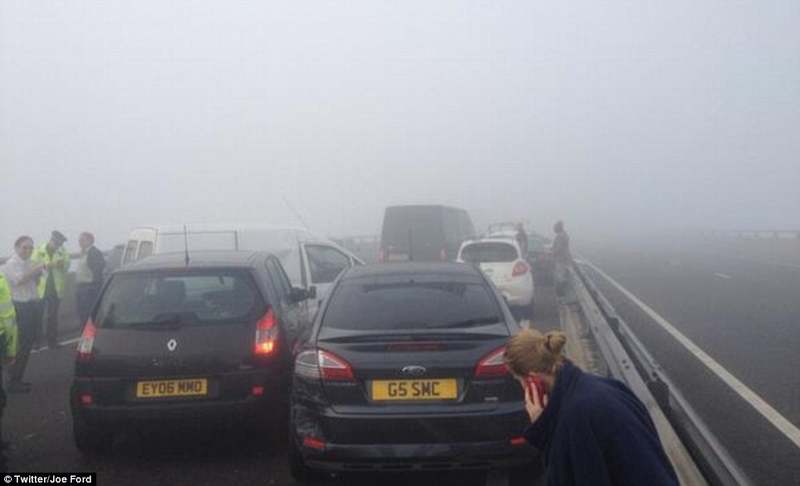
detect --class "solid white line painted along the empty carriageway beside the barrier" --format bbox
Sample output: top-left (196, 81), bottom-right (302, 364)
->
top-left (586, 262), bottom-right (800, 448)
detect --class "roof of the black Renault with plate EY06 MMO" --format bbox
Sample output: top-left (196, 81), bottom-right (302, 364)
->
top-left (118, 250), bottom-right (271, 273)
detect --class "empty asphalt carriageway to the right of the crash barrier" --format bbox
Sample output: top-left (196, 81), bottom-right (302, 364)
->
top-left (581, 246), bottom-right (800, 485)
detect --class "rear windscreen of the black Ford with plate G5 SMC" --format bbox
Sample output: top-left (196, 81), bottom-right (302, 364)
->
top-left (322, 279), bottom-right (502, 334)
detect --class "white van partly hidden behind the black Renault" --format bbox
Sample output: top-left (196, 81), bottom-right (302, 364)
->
top-left (121, 224), bottom-right (364, 315)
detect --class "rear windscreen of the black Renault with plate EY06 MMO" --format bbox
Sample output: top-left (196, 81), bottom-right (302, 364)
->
top-left (95, 270), bottom-right (264, 328)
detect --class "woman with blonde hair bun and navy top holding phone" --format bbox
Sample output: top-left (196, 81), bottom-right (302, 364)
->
top-left (504, 329), bottom-right (680, 486)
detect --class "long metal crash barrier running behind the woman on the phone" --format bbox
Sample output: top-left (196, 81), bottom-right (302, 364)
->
top-left (570, 264), bottom-right (753, 486)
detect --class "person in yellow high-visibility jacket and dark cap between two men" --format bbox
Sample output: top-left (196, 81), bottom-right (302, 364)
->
top-left (31, 231), bottom-right (70, 349)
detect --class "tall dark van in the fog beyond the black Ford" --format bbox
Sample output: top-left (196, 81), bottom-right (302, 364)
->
top-left (379, 206), bottom-right (475, 262)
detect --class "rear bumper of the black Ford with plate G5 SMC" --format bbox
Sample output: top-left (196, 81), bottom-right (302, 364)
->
top-left (291, 403), bottom-right (536, 471)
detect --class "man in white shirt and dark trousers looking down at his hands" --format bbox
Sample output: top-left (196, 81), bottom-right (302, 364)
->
top-left (2, 236), bottom-right (44, 393)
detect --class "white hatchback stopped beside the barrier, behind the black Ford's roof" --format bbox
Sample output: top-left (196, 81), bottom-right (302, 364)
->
top-left (457, 237), bottom-right (535, 318)
